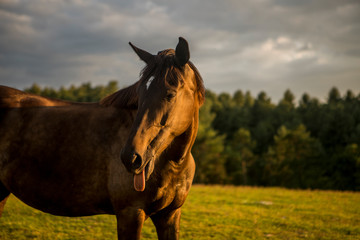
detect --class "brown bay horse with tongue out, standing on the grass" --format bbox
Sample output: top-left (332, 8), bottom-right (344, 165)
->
top-left (0, 37), bottom-right (205, 239)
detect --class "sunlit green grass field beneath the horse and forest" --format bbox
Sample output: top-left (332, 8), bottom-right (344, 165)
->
top-left (0, 185), bottom-right (360, 240)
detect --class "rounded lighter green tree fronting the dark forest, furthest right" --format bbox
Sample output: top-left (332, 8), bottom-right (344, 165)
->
top-left (264, 125), bottom-right (324, 188)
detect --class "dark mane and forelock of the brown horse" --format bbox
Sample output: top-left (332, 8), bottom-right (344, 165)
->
top-left (100, 49), bottom-right (205, 109)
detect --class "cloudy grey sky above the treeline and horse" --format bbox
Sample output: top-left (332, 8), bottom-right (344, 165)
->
top-left (0, 0), bottom-right (360, 102)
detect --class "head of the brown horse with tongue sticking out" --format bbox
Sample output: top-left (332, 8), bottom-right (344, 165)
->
top-left (121, 37), bottom-right (204, 191)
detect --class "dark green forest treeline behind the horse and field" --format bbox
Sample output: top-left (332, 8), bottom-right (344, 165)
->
top-left (25, 81), bottom-right (360, 191)
